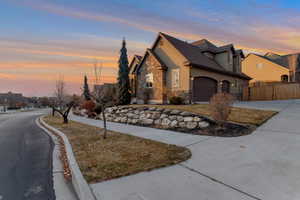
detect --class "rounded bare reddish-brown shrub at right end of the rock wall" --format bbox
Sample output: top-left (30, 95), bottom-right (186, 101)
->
top-left (209, 93), bottom-right (234, 127)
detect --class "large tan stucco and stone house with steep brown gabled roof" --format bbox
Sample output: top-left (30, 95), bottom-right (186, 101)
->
top-left (130, 33), bottom-right (251, 103)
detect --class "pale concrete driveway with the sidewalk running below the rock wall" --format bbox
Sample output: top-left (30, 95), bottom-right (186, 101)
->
top-left (72, 100), bottom-right (300, 200)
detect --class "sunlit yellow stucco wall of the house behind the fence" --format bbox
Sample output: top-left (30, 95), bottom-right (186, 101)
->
top-left (242, 54), bottom-right (289, 82)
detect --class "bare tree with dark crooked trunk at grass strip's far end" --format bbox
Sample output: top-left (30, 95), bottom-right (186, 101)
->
top-left (52, 77), bottom-right (74, 124)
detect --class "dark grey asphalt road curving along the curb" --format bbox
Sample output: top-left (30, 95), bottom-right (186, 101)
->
top-left (0, 112), bottom-right (55, 200)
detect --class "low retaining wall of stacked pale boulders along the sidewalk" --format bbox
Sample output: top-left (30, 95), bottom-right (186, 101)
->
top-left (96, 106), bottom-right (215, 131)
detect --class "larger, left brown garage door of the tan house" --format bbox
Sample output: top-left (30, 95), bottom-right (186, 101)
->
top-left (193, 77), bottom-right (218, 102)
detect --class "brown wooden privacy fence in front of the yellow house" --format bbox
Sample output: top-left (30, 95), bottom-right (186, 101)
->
top-left (243, 83), bottom-right (300, 101)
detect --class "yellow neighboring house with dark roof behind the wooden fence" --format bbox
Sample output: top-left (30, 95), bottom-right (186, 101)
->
top-left (242, 53), bottom-right (300, 82)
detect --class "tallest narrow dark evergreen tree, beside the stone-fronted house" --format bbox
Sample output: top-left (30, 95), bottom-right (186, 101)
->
top-left (118, 39), bottom-right (131, 105)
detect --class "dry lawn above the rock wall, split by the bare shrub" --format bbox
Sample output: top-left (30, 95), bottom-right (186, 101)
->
top-left (132, 104), bottom-right (277, 126)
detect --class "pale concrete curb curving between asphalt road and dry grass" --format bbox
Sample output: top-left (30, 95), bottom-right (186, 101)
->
top-left (40, 117), bottom-right (96, 200)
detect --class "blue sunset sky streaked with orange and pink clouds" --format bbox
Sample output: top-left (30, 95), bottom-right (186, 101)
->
top-left (0, 0), bottom-right (300, 96)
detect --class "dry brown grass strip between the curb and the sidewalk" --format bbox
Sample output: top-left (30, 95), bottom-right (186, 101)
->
top-left (44, 116), bottom-right (191, 183)
